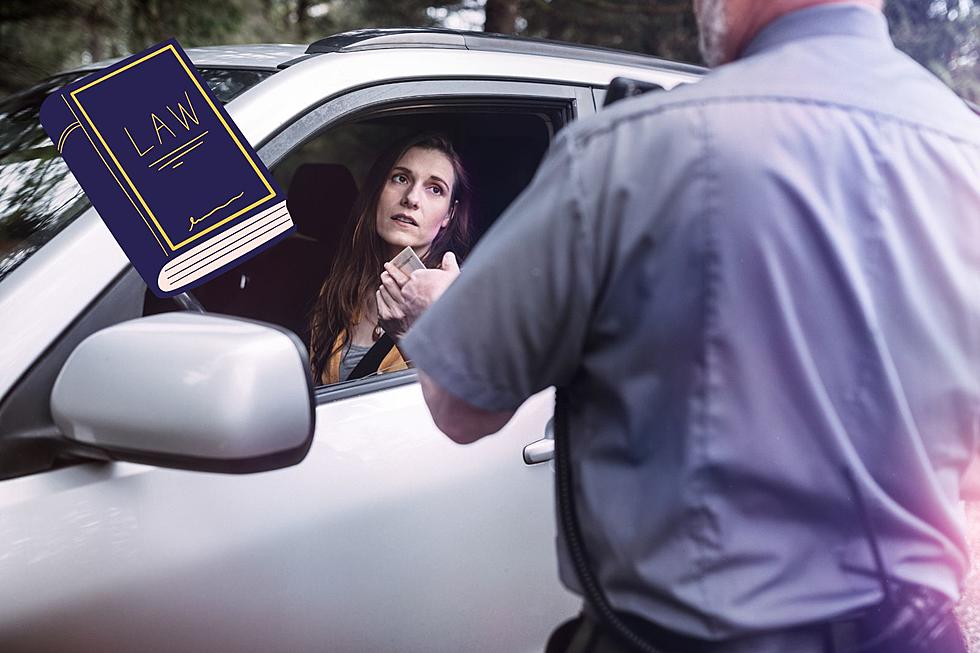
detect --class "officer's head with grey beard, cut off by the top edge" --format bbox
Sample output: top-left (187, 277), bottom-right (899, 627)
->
top-left (694, 0), bottom-right (883, 67)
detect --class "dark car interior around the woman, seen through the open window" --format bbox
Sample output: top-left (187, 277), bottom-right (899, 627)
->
top-left (143, 103), bottom-right (564, 384)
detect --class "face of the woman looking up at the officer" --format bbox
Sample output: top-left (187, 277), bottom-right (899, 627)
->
top-left (376, 147), bottom-right (456, 257)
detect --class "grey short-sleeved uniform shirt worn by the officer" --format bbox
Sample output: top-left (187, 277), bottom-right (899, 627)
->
top-left (403, 5), bottom-right (980, 638)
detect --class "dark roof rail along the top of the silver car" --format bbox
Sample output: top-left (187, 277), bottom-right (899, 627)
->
top-left (306, 27), bottom-right (705, 74)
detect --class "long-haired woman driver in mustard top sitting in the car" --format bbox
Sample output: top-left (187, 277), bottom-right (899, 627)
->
top-left (310, 134), bottom-right (469, 384)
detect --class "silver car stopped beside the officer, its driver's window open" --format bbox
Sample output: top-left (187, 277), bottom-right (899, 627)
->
top-left (0, 30), bottom-right (701, 653)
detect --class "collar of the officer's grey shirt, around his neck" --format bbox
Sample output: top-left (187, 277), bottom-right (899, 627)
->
top-left (739, 3), bottom-right (891, 59)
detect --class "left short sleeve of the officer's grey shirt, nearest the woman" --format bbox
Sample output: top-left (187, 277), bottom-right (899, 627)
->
top-left (402, 130), bottom-right (597, 411)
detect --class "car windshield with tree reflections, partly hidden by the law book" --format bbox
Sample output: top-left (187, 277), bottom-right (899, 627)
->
top-left (0, 68), bottom-right (272, 279)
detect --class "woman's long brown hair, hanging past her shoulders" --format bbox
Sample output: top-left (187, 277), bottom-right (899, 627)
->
top-left (309, 134), bottom-right (470, 383)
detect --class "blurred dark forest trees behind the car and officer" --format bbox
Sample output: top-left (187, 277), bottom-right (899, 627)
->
top-left (0, 0), bottom-right (980, 102)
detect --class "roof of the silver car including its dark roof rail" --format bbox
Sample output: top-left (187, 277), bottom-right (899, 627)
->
top-left (67, 27), bottom-right (705, 74)
